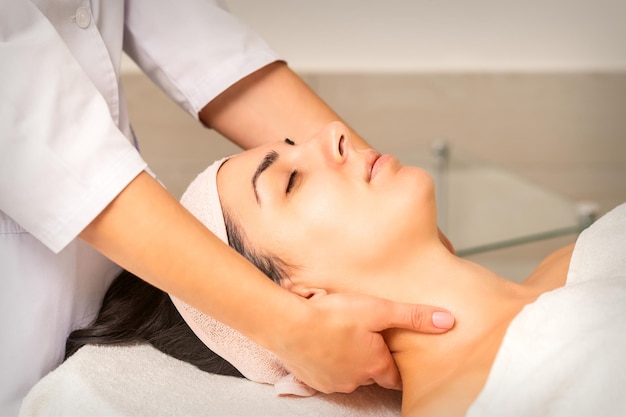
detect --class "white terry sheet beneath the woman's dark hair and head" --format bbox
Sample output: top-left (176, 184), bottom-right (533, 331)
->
top-left (20, 345), bottom-right (401, 417)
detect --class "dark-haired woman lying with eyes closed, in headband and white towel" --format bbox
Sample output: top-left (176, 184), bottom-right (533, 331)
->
top-left (68, 123), bottom-right (626, 416)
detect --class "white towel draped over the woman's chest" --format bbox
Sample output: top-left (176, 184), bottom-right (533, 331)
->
top-left (467, 204), bottom-right (626, 417)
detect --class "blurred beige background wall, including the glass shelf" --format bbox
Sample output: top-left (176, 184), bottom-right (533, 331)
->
top-left (122, 0), bottom-right (626, 280)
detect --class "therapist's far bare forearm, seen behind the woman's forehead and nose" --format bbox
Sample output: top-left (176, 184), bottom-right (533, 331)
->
top-left (199, 62), bottom-right (369, 149)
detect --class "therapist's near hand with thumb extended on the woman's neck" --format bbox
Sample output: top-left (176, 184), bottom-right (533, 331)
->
top-left (277, 293), bottom-right (454, 393)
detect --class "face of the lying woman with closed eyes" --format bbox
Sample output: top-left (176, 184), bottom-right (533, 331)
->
top-left (217, 122), bottom-right (438, 292)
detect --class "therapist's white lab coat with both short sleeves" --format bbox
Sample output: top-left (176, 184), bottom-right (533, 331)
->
top-left (0, 0), bottom-right (278, 415)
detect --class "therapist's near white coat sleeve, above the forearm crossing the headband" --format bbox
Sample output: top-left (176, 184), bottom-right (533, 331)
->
top-left (0, 0), bottom-right (146, 252)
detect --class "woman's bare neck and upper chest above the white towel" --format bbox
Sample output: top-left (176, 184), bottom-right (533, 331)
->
top-left (368, 245), bottom-right (564, 415)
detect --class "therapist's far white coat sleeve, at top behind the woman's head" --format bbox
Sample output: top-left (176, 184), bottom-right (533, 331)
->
top-left (124, 0), bottom-right (279, 118)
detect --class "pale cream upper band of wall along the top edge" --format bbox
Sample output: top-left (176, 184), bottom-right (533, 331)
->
top-left (224, 0), bottom-right (626, 72)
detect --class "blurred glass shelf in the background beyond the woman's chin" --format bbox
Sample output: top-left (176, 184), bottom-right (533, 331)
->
top-left (399, 142), bottom-right (594, 256)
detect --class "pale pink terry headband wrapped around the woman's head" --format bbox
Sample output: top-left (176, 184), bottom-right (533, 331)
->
top-left (170, 158), bottom-right (316, 396)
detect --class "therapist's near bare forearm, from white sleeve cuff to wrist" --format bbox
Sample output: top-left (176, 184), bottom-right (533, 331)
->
top-left (80, 172), bottom-right (302, 347)
